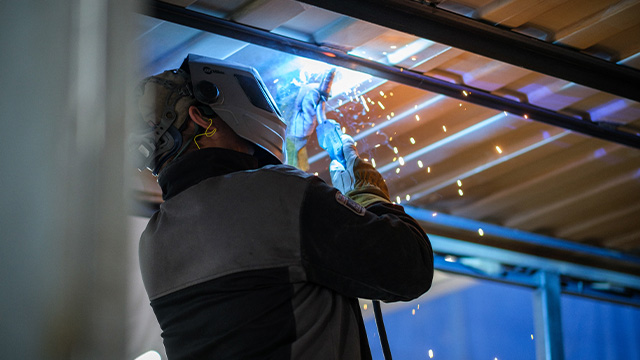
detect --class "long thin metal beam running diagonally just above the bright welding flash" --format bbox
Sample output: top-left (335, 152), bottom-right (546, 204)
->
top-left (143, 0), bottom-right (640, 149)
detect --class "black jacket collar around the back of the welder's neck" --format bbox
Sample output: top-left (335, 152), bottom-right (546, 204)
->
top-left (158, 148), bottom-right (259, 200)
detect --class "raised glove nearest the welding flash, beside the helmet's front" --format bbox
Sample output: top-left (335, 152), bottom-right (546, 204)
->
top-left (285, 84), bottom-right (321, 171)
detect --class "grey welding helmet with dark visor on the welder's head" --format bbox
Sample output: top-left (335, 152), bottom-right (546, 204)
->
top-left (133, 54), bottom-right (286, 175)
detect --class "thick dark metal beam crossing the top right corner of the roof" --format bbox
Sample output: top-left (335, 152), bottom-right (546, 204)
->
top-left (299, 0), bottom-right (640, 101)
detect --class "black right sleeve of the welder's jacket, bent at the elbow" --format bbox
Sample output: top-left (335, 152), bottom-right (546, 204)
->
top-left (300, 178), bottom-right (433, 302)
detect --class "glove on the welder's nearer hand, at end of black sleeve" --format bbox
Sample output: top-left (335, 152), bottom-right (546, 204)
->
top-left (329, 134), bottom-right (391, 207)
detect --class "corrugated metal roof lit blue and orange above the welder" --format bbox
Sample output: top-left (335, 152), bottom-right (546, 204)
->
top-left (132, 0), bottom-right (640, 264)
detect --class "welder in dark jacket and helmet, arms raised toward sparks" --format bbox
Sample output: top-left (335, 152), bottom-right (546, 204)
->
top-left (131, 54), bottom-right (433, 360)
